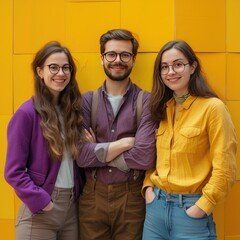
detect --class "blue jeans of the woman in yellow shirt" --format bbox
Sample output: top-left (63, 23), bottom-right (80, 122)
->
top-left (142, 187), bottom-right (216, 240)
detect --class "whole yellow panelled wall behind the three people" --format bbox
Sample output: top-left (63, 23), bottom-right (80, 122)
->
top-left (0, 0), bottom-right (240, 240)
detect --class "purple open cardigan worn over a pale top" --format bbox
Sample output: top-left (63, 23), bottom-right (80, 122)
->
top-left (4, 98), bottom-right (83, 213)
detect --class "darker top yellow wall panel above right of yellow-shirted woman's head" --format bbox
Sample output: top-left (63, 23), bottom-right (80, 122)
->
top-left (175, 0), bottom-right (226, 52)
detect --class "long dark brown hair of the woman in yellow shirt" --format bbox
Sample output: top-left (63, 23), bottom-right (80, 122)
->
top-left (150, 40), bottom-right (218, 121)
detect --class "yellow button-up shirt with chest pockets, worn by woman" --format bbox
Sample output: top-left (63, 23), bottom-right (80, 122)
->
top-left (143, 96), bottom-right (237, 214)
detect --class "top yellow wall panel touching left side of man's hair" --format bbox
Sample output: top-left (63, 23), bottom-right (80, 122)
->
top-left (66, 2), bottom-right (120, 53)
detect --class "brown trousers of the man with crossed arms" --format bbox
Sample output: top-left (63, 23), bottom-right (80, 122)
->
top-left (79, 179), bottom-right (145, 240)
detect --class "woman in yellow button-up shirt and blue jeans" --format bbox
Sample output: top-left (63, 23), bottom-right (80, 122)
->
top-left (143, 41), bottom-right (236, 240)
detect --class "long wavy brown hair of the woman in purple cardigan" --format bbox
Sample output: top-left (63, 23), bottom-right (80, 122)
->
top-left (32, 41), bottom-right (83, 160)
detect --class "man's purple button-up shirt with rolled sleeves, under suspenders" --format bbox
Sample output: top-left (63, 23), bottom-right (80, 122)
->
top-left (77, 82), bottom-right (156, 184)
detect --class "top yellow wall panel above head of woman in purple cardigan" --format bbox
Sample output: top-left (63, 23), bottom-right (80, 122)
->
top-left (13, 0), bottom-right (66, 54)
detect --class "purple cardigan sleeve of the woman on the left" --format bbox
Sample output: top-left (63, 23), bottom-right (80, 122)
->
top-left (4, 104), bottom-right (51, 213)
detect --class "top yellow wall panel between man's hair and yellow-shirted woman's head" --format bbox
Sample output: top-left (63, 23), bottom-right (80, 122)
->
top-left (121, 0), bottom-right (174, 52)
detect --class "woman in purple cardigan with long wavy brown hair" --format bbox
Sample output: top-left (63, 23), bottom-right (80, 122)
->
top-left (5, 42), bottom-right (82, 240)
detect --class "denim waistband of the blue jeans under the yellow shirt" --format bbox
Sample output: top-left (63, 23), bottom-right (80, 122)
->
top-left (154, 186), bottom-right (202, 206)
